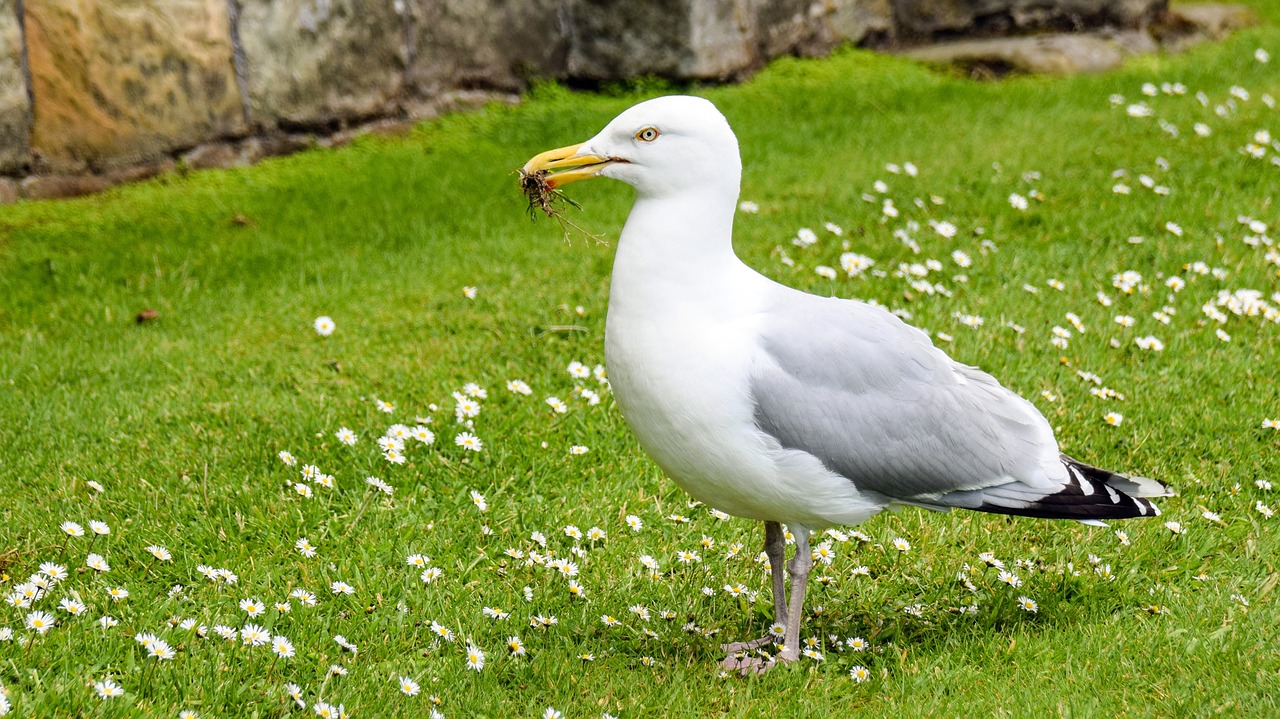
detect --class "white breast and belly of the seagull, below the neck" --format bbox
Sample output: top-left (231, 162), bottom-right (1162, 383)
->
top-left (605, 258), bottom-right (881, 527)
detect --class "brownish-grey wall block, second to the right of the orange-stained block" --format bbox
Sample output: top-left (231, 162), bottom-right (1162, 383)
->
top-left (406, 0), bottom-right (572, 101)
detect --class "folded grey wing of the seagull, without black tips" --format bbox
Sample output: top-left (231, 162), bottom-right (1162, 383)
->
top-left (751, 296), bottom-right (1066, 502)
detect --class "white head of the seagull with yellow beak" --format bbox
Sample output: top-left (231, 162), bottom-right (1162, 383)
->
top-left (524, 95), bottom-right (742, 197)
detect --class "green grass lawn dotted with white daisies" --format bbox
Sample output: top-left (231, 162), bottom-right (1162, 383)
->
top-left (0, 9), bottom-right (1280, 718)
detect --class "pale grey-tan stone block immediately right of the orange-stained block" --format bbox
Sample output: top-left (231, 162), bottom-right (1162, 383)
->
top-left (237, 0), bottom-right (407, 129)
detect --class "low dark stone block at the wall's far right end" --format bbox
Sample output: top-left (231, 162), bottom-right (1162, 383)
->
top-left (892, 0), bottom-right (1167, 40)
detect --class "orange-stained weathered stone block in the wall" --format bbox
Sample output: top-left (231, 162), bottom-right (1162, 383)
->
top-left (24, 0), bottom-right (244, 171)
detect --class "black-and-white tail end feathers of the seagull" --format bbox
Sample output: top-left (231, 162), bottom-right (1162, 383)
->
top-left (931, 454), bottom-right (1172, 521)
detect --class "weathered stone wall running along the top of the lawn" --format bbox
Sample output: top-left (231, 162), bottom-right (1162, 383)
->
top-left (0, 0), bottom-right (1166, 202)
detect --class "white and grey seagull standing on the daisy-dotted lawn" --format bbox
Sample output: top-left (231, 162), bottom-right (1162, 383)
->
top-left (524, 96), bottom-right (1170, 673)
